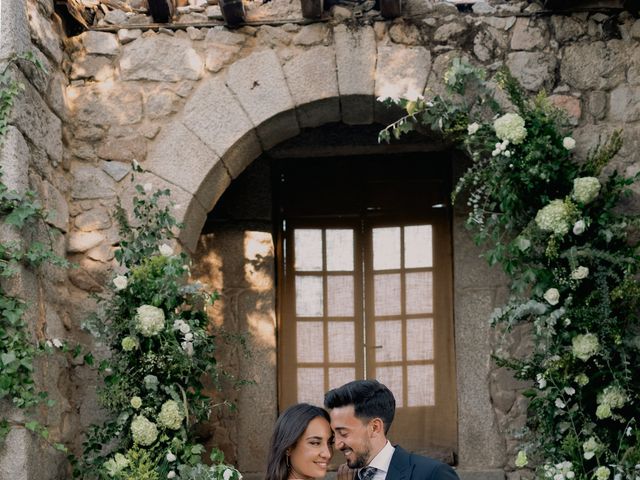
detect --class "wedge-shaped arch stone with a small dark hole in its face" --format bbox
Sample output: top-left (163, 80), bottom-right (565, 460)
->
top-left (226, 50), bottom-right (300, 150)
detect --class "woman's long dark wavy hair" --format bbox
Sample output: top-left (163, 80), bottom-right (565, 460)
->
top-left (265, 403), bottom-right (331, 480)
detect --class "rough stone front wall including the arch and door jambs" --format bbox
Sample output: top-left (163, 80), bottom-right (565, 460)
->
top-left (57, 2), bottom-right (640, 478)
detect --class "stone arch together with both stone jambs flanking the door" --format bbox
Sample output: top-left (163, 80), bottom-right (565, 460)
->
top-left (130, 43), bottom-right (504, 478)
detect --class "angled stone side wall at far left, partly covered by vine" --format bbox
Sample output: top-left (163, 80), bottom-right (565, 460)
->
top-left (0, 0), bottom-right (77, 480)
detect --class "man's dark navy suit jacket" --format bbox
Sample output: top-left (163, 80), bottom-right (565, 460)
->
top-left (386, 445), bottom-right (459, 480)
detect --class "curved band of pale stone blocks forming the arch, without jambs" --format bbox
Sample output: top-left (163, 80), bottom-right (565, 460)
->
top-left (145, 30), bottom-right (431, 253)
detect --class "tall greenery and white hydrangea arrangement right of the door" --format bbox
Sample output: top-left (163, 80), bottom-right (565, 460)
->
top-left (380, 60), bottom-right (640, 480)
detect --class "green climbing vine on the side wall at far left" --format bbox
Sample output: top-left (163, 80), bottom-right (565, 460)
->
top-left (0, 53), bottom-right (67, 451)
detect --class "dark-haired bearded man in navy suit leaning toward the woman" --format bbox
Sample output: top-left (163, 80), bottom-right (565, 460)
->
top-left (324, 380), bottom-right (458, 480)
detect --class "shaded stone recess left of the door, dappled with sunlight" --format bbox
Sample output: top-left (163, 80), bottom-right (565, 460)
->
top-left (193, 158), bottom-right (277, 473)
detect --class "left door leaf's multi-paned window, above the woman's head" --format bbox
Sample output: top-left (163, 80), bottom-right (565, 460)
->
top-left (280, 224), bottom-right (363, 407)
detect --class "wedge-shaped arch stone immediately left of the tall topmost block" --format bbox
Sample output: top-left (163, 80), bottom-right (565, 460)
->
top-left (283, 46), bottom-right (340, 128)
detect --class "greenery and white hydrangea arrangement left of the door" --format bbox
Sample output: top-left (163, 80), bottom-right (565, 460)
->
top-left (75, 173), bottom-right (241, 480)
